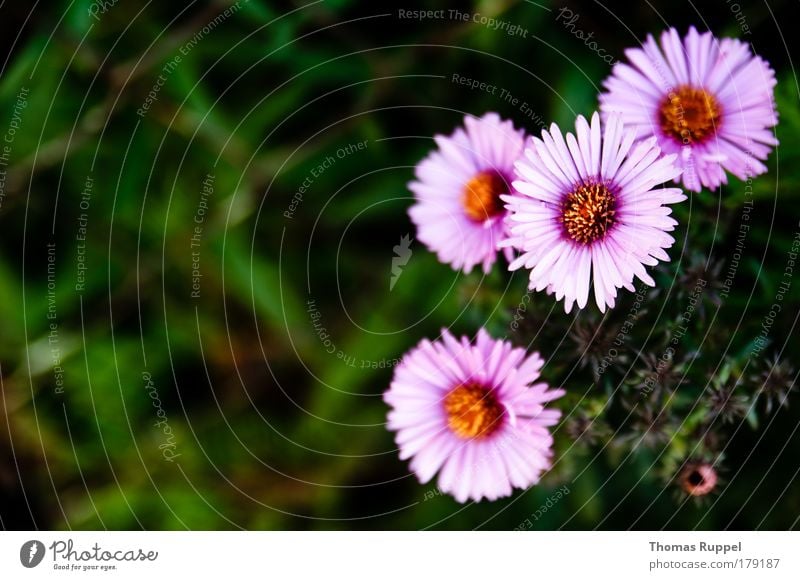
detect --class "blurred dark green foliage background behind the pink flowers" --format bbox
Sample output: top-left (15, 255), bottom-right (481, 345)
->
top-left (0, 0), bottom-right (800, 529)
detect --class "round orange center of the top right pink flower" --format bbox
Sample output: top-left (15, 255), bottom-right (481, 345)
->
top-left (658, 85), bottom-right (721, 145)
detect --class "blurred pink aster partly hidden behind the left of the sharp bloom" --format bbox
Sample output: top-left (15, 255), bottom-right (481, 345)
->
top-left (408, 113), bottom-right (525, 273)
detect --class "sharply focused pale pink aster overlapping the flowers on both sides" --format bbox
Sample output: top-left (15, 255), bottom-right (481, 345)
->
top-left (503, 113), bottom-right (686, 312)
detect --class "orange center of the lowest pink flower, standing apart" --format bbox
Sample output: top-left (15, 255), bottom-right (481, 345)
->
top-left (444, 383), bottom-right (505, 439)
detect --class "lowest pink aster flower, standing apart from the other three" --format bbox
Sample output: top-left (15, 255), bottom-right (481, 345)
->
top-left (384, 329), bottom-right (564, 503)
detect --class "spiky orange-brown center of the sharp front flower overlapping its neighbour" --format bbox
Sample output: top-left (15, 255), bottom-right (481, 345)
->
top-left (561, 182), bottom-right (616, 244)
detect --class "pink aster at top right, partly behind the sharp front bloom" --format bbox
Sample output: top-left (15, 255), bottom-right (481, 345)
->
top-left (600, 27), bottom-right (778, 191)
